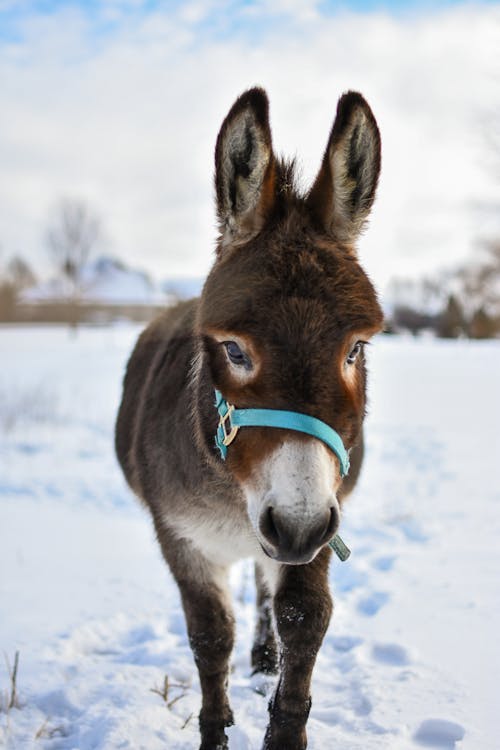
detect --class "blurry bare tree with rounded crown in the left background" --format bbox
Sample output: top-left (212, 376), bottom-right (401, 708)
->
top-left (46, 198), bottom-right (101, 325)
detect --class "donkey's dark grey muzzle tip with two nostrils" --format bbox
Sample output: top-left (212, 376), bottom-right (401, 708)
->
top-left (259, 505), bottom-right (340, 565)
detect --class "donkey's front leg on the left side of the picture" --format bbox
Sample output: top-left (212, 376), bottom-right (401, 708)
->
top-left (156, 533), bottom-right (234, 750)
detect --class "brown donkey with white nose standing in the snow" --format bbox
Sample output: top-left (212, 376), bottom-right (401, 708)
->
top-left (116, 88), bottom-right (382, 750)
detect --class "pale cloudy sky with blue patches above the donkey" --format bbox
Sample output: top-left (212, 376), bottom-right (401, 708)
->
top-left (0, 0), bottom-right (500, 289)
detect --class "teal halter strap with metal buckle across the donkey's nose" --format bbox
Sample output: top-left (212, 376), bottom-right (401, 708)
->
top-left (215, 390), bottom-right (349, 477)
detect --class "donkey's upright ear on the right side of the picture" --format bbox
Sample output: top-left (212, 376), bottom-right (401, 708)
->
top-left (307, 91), bottom-right (380, 244)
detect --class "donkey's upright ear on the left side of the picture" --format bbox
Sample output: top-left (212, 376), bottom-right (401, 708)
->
top-left (215, 88), bottom-right (275, 244)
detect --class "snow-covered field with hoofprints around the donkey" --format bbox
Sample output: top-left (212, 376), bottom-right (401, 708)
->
top-left (0, 326), bottom-right (500, 750)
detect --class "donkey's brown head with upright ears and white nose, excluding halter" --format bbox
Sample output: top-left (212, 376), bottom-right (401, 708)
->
top-left (197, 88), bottom-right (382, 564)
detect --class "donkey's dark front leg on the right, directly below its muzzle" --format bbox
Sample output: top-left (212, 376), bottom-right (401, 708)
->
top-left (263, 549), bottom-right (332, 750)
